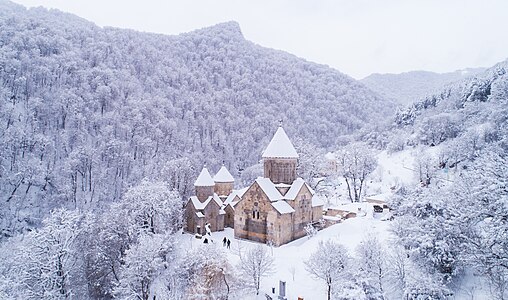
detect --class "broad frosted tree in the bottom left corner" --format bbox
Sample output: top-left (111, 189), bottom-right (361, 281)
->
top-left (12, 209), bottom-right (86, 299)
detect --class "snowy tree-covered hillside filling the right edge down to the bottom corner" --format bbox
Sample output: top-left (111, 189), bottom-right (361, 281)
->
top-left (380, 61), bottom-right (508, 299)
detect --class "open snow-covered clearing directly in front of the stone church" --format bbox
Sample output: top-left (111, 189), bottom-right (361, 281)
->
top-left (182, 215), bottom-right (390, 299)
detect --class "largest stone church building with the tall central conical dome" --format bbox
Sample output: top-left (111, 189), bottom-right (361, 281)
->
top-left (234, 127), bottom-right (323, 246)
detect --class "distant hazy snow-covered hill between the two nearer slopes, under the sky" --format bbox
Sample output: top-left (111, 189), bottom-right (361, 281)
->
top-left (361, 68), bottom-right (485, 106)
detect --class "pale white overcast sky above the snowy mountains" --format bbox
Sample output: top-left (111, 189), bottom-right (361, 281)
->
top-left (9, 0), bottom-right (508, 79)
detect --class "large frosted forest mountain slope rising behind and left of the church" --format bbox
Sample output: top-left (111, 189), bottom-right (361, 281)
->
top-left (0, 1), bottom-right (393, 234)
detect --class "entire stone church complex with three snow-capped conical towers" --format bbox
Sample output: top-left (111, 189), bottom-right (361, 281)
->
top-left (184, 127), bottom-right (323, 246)
